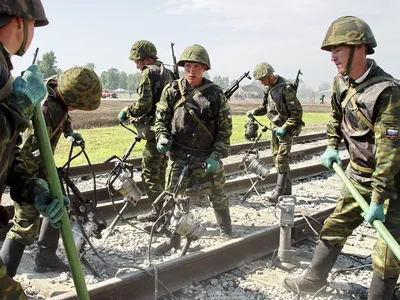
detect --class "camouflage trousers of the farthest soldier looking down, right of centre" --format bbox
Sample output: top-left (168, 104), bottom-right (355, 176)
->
top-left (271, 132), bottom-right (293, 172)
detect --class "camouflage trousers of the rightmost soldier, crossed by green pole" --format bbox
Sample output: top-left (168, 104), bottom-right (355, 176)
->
top-left (320, 180), bottom-right (400, 279)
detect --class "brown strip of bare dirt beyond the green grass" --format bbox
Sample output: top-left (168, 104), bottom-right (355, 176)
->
top-left (70, 99), bottom-right (330, 129)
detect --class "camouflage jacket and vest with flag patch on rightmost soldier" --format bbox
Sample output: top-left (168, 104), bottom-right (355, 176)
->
top-left (327, 59), bottom-right (400, 203)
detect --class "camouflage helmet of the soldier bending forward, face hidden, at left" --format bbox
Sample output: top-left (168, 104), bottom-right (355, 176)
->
top-left (57, 67), bottom-right (102, 110)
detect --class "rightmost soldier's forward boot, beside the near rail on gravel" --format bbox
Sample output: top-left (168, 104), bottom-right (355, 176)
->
top-left (283, 241), bottom-right (343, 294)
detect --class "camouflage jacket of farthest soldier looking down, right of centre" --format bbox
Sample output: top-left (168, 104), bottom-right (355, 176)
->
top-left (254, 76), bottom-right (304, 132)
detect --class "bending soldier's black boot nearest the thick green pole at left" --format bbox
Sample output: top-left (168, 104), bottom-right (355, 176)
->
top-left (35, 218), bottom-right (69, 273)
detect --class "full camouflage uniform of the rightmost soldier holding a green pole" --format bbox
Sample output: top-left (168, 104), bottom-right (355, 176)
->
top-left (321, 59), bottom-right (400, 278)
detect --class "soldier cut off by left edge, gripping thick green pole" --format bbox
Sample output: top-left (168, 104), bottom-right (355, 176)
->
top-left (0, 0), bottom-right (63, 299)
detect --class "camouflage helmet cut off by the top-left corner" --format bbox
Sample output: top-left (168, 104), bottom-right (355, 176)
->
top-left (0, 0), bottom-right (49, 27)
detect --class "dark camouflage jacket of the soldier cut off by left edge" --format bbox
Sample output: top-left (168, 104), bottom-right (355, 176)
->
top-left (0, 43), bottom-right (45, 203)
